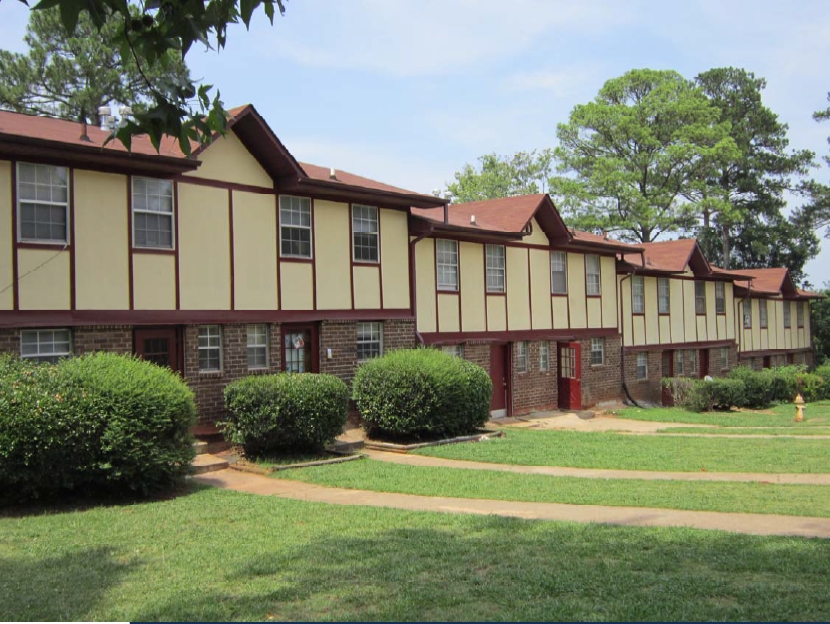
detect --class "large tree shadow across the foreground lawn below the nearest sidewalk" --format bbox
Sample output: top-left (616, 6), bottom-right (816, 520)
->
top-left (133, 509), bottom-right (830, 621)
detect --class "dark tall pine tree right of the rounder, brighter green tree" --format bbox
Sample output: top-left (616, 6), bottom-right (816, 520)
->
top-left (687, 67), bottom-right (815, 268)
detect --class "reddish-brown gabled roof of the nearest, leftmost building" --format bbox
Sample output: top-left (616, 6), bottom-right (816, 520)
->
top-left (0, 104), bottom-right (446, 209)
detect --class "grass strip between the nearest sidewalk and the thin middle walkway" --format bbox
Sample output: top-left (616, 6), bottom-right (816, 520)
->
top-left (278, 459), bottom-right (830, 518)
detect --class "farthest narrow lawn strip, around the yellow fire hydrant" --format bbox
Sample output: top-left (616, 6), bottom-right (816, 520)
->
top-left (614, 401), bottom-right (830, 429)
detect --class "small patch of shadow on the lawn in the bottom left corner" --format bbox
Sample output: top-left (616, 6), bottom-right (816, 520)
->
top-left (0, 540), bottom-right (136, 622)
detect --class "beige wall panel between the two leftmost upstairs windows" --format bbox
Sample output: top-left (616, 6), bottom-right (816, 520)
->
top-left (74, 169), bottom-right (132, 310)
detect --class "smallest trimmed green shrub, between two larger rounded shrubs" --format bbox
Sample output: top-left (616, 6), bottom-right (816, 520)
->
top-left (218, 373), bottom-right (349, 457)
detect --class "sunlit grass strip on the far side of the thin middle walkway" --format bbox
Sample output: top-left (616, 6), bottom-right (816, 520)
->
top-left (415, 429), bottom-right (830, 473)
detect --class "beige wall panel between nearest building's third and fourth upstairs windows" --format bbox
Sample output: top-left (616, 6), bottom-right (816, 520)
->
top-left (314, 199), bottom-right (350, 310)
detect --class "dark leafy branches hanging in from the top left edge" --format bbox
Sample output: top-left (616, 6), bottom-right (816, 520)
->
top-left (5, 0), bottom-right (285, 154)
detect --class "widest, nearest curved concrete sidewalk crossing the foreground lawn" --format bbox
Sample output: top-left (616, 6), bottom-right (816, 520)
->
top-left (193, 469), bottom-right (830, 539)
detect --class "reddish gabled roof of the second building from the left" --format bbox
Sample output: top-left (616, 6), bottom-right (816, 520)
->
top-left (411, 193), bottom-right (640, 252)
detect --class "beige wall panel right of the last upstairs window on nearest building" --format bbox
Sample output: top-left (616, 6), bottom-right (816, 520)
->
top-left (382, 208), bottom-right (409, 309)
